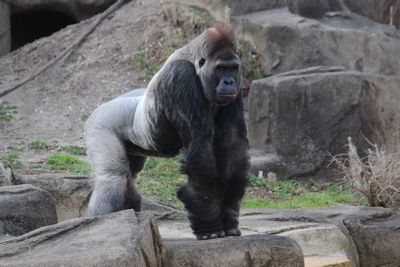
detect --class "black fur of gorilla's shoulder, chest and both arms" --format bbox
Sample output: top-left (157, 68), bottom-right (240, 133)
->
top-left (155, 60), bottom-right (249, 235)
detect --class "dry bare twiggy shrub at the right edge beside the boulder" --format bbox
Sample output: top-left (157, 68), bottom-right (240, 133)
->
top-left (332, 137), bottom-right (400, 207)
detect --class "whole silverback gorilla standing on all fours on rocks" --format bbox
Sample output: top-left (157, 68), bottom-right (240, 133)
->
top-left (85, 23), bottom-right (249, 239)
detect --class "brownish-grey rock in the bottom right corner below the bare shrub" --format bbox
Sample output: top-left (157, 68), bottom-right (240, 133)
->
top-left (344, 214), bottom-right (400, 267)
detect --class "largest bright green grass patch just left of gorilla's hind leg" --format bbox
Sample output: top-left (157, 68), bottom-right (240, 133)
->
top-left (44, 153), bottom-right (90, 175)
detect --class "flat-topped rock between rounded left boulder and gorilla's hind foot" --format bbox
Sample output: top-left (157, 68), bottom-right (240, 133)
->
top-left (15, 174), bottom-right (92, 222)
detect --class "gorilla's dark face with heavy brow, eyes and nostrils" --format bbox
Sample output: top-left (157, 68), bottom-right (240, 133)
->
top-left (198, 54), bottom-right (241, 106)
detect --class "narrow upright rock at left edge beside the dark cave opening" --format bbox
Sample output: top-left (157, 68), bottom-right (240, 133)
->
top-left (0, 1), bottom-right (11, 57)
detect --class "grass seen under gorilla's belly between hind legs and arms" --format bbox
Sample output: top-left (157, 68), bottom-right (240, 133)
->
top-left (138, 157), bottom-right (186, 209)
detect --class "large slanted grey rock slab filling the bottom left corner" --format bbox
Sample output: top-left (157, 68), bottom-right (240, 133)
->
top-left (0, 210), bottom-right (162, 267)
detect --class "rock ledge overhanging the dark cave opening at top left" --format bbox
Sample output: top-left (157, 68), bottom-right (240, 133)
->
top-left (12, 0), bottom-right (115, 20)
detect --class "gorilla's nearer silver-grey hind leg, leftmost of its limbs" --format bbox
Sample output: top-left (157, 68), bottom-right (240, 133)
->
top-left (86, 130), bottom-right (131, 216)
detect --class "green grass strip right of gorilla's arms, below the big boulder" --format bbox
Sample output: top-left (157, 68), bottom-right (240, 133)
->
top-left (241, 181), bottom-right (366, 209)
